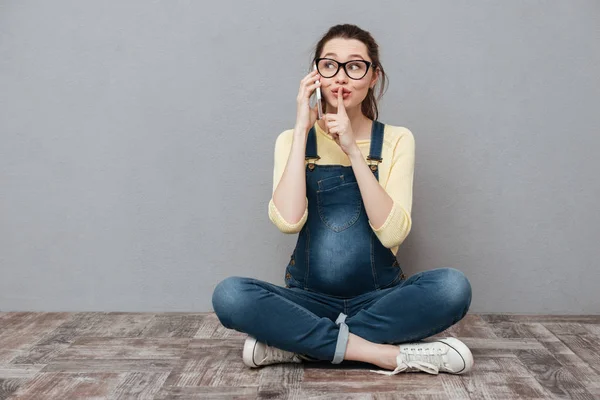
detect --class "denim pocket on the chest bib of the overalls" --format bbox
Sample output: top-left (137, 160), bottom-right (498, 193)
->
top-left (317, 182), bottom-right (362, 232)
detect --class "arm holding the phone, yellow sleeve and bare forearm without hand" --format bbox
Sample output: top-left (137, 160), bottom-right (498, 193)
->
top-left (269, 128), bottom-right (308, 233)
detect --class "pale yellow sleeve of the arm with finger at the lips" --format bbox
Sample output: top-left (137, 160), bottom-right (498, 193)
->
top-left (369, 129), bottom-right (415, 249)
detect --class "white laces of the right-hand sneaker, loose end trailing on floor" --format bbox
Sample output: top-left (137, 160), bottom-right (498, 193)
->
top-left (371, 345), bottom-right (445, 376)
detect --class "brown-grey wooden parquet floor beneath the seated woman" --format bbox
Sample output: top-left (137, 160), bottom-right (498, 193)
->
top-left (0, 313), bottom-right (600, 400)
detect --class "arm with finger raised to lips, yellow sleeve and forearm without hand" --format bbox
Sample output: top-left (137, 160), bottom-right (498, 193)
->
top-left (349, 130), bottom-right (415, 248)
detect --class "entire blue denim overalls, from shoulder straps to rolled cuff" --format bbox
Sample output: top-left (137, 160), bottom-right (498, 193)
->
top-left (212, 121), bottom-right (471, 364)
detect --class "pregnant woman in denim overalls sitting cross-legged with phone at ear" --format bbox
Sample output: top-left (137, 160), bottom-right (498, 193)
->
top-left (212, 24), bottom-right (473, 375)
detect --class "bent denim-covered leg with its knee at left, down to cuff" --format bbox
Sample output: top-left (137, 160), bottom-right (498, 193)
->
top-left (212, 277), bottom-right (345, 361)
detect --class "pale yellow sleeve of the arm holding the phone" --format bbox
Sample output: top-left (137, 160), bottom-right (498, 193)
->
top-left (269, 130), bottom-right (308, 233)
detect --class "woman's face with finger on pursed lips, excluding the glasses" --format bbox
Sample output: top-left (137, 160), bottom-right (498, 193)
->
top-left (319, 38), bottom-right (377, 112)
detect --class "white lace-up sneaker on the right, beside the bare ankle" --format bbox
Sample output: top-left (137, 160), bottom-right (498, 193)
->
top-left (371, 337), bottom-right (473, 375)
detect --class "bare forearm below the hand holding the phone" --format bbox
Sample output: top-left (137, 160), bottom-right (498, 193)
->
top-left (273, 128), bottom-right (308, 224)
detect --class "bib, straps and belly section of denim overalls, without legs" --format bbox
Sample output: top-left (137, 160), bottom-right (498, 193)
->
top-left (285, 121), bottom-right (405, 298)
